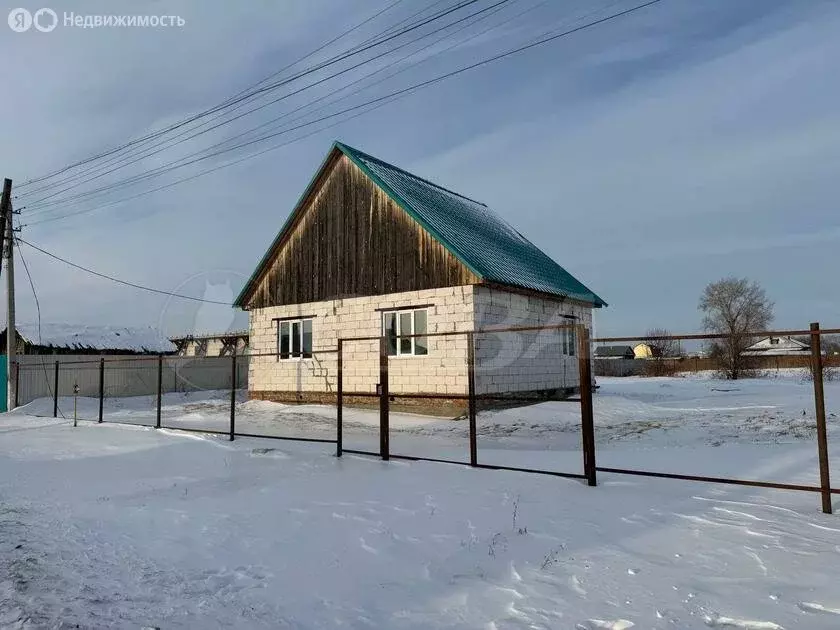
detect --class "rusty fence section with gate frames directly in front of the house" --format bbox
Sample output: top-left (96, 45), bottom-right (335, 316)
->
top-left (344, 324), bottom-right (594, 478)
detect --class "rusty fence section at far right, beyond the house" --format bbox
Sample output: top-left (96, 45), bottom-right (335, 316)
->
top-left (595, 324), bottom-right (840, 512)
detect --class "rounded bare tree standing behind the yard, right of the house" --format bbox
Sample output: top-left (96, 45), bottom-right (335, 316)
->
top-left (699, 277), bottom-right (773, 379)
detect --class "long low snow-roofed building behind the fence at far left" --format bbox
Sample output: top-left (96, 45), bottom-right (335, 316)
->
top-left (0, 322), bottom-right (176, 354)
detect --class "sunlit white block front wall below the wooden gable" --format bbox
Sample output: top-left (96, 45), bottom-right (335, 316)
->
top-left (248, 286), bottom-right (474, 394)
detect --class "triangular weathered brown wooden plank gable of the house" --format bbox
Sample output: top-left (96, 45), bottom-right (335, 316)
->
top-left (244, 151), bottom-right (479, 309)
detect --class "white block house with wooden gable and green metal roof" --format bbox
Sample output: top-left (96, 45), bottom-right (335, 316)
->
top-left (235, 142), bottom-right (606, 412)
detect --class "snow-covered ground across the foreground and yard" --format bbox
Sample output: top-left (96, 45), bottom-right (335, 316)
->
top-left (0, 373), bottom-right (840, 630)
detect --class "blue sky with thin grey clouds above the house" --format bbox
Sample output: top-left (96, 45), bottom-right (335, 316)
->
top-left (0, 0), bottom-right (840, 335)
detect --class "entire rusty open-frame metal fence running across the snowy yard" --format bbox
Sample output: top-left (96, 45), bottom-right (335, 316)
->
top-left (13, 323), bottom-right (840, 513)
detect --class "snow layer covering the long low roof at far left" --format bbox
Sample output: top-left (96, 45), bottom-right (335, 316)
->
top-left (17, 322), bottom-right (176, 352)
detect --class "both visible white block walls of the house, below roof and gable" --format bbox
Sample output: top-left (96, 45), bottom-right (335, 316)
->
top-left (248, 285), bottom-right (592, 394)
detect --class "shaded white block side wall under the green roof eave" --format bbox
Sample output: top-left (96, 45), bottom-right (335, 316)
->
top-left (473, 286), bottom-right (592, 394)
